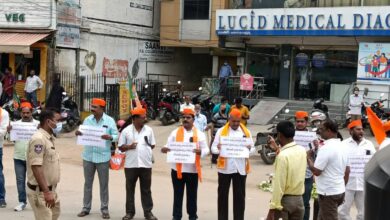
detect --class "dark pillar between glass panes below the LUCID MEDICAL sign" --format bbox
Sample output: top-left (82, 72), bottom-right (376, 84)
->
top-left (279, 45), bottom-right (292, 99)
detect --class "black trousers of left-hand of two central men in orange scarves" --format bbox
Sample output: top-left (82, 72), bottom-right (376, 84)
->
top-left (171, 170), bottom-right (198, 220)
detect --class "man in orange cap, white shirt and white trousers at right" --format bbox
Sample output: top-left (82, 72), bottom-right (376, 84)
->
top-left (339, 120), bottom-right (375, 220)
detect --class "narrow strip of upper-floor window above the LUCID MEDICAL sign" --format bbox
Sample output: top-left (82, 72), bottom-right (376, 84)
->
top-left (229, 0), bottom-right (390, 8)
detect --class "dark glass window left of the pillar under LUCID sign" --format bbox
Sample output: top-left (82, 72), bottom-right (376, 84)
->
top-left (247, 47), bottom-right (280, 97)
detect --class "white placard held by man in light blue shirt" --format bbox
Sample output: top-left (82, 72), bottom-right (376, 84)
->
top-left (77, 125), bottom-right (106, 147)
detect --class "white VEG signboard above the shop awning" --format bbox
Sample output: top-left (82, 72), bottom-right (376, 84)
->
top-left (0, 0), bottom-right (55, 29)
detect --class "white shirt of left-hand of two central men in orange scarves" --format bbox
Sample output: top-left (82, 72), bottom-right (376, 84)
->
top-left (166, 128), bottom-right (210, 173)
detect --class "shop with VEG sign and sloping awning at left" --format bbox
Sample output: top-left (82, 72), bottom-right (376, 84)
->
top-left (0, 0), bottom-right (56, 101)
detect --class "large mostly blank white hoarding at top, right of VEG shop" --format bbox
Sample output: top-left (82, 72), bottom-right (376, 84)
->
top-left (81, 0), bottom-right (154, 28)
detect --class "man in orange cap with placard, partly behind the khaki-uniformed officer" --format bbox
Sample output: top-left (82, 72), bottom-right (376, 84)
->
top-left (7, 102), bottom-right (39, 212)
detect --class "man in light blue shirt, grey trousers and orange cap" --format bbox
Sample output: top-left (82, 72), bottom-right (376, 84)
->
top-left (76, 98), bottom-right (118, 219)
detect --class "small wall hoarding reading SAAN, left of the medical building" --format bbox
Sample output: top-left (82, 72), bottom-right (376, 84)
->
top-left (138, 41), bottom-right (174, 62)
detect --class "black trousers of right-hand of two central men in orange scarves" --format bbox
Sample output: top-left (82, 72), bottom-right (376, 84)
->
top-left (218, 173), bottom-right (246, 220)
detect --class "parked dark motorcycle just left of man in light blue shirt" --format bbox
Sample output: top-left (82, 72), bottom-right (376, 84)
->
top-left (61, 92), bottom-right (81, 132)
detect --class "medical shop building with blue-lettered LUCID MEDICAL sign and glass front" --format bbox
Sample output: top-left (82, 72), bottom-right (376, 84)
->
top-left (215, 0), bottom-right (390, 102)
